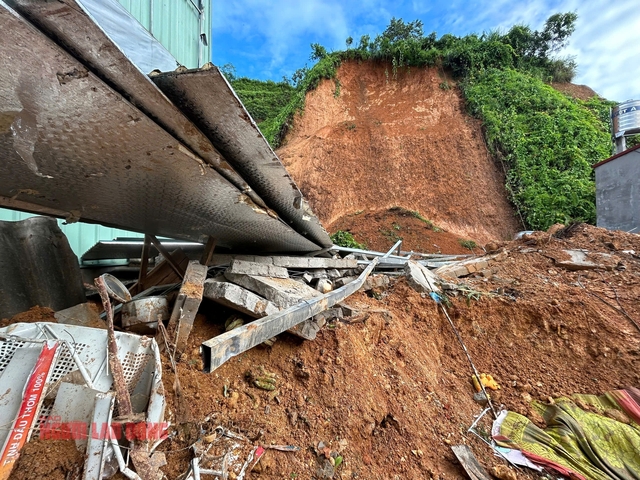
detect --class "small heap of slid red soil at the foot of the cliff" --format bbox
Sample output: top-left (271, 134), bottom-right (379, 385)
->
top-left (327, 207), bottom-right (483, 254)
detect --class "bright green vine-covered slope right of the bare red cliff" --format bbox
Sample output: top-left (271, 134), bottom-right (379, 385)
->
top-left (462, 69), bottom-right (611, 229)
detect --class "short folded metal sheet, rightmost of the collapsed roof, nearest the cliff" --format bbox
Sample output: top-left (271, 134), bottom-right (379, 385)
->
top-left (153, 66), bottom-right (333, 247)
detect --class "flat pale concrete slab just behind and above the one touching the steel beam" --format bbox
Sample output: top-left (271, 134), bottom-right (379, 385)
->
top-left (224, 273), bottom-right (321, 308)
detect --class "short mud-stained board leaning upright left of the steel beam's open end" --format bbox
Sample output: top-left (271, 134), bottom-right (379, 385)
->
top-left (167, 260), bottom-right (209, 358)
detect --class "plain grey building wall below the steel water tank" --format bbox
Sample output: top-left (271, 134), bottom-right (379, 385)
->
top-left (595, 149), bottom-right (640, 233)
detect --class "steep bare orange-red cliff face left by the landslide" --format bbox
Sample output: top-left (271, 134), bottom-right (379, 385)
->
top-left (278, 62), bottom-right (520, 242)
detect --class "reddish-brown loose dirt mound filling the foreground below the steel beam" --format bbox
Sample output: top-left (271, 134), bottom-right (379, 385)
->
top-left (154, 225), bottom-right (640, 479)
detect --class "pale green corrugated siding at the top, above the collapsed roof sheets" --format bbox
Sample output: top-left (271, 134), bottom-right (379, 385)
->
top-left (118, 0), bottom-right (211, 68)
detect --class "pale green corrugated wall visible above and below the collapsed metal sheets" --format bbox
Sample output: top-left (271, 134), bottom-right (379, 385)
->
top-left (0, 0), bottom-right (211, 258)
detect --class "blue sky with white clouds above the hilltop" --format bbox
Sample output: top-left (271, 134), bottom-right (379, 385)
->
top-left (212, 0), bottom-right (640, 101)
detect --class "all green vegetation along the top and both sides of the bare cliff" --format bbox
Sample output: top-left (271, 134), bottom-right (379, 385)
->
top-left (231, 12), bottom-right (616, 231)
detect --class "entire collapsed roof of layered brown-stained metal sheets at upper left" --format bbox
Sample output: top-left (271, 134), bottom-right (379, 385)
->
top-left (0, 0), bottom-right (331, 252)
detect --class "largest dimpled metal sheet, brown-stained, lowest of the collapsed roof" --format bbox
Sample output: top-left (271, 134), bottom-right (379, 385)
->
top-left (0, 1), bottom-right (317, 252)
